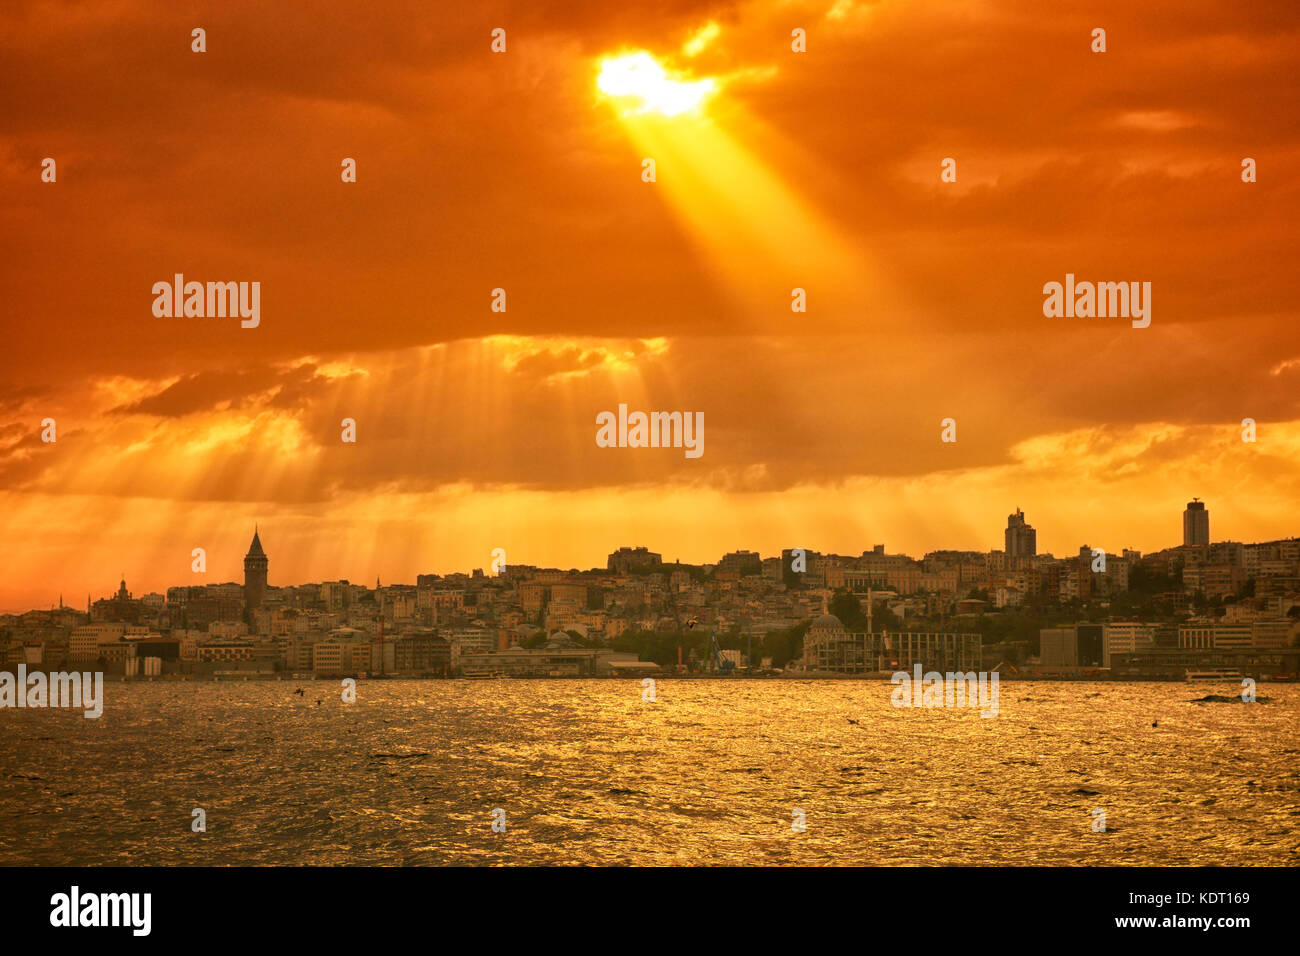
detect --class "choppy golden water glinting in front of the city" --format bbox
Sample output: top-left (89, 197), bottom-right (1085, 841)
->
top-left (0, 679), bottom-right (1300, 865)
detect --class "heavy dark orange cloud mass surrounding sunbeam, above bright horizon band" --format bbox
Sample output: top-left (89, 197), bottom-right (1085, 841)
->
top-left (0, 0), bottom-right (1300, 530)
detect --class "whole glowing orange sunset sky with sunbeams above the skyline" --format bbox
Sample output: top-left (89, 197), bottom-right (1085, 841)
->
top-left (0, 0), bottom-right (1300, 610)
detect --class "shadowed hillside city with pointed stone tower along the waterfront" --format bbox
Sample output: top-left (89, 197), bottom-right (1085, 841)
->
top-left (0, 499), bottom-right (1300, 680)
